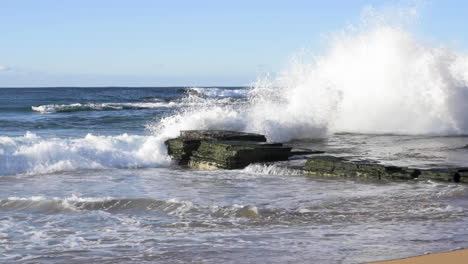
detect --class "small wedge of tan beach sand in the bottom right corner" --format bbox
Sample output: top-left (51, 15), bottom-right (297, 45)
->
top-left (367, 249), bottom-right (468, 264)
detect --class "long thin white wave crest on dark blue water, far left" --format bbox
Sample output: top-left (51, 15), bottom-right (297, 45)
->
top-left (31, 102), bottom-right (178, 114)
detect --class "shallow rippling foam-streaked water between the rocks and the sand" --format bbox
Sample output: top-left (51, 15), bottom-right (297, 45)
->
top-left (0, 168), bottom-right (468, 263)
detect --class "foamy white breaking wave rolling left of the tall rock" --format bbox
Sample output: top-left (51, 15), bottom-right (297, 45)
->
top-left (0, 132), bottom-right (170, 175)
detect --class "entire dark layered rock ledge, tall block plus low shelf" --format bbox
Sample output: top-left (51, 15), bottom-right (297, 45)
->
top-left (166, 130), bottom-right (468, 183)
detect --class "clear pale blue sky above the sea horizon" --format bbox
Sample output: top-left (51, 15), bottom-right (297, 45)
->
top-left (0, 0), bottom-right (468, 87)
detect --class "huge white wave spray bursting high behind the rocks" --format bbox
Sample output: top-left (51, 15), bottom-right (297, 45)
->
top-left (153, 6), bottom-right (468, 141)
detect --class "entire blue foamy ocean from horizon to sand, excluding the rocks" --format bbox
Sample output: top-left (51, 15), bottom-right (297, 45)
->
top-left (0, 84), bottom-right (468, 263)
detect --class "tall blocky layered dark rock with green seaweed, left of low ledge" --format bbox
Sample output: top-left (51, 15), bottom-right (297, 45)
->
top-left (166, 130), bottom-right (291, 169)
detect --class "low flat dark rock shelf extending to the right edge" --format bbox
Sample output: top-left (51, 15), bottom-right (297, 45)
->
top-left (304, 156), bottom-right (468, 183)
